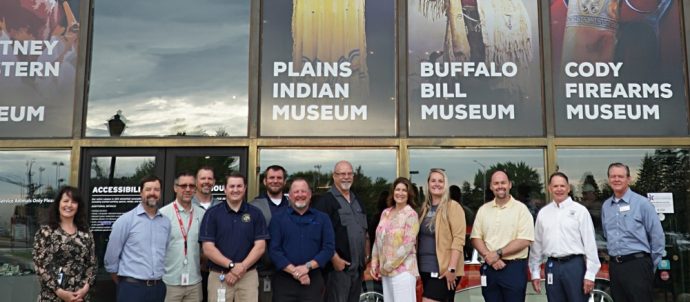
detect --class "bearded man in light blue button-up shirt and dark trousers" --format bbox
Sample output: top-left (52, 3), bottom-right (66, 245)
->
top-left (104, 176), bottom-right (170, 302)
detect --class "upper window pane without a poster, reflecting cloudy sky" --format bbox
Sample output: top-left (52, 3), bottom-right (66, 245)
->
top-left (86, 0), bottom-right (250, 136)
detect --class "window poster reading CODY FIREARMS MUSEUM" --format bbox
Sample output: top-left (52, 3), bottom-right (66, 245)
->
top-left (550, 0), bottom-right (688, 136)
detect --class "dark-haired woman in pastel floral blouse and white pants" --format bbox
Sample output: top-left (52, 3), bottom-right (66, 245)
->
top-left (371, 177), bottom-right (419, 302)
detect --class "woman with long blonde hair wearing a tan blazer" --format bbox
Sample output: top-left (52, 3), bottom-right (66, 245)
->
top-left (418, 169), bottom-right (466, 302)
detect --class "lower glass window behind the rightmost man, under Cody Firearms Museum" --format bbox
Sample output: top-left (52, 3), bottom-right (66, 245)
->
top-left (557, 148), bottom-right (690, 301)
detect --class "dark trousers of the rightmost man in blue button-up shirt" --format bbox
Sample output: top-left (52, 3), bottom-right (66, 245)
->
top-left (609, 256), bottom-right (654, 302)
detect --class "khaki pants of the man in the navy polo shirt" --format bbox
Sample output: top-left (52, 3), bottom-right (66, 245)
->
top-left (208, 269), bottom-right (259, 302)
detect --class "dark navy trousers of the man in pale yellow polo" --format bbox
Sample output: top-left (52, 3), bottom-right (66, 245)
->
top-left (481, 259), bottom-right (527, 302)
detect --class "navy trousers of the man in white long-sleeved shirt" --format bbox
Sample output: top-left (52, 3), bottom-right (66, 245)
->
top-left (544, 256), bottom-right (589, 302)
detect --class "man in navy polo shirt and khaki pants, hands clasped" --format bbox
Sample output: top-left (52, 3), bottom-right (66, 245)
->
top-left (199, 172), bottom-right (269, 302)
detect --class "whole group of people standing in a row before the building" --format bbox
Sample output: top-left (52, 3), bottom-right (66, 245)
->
top-left (34, 161), bottom-right (664, 302)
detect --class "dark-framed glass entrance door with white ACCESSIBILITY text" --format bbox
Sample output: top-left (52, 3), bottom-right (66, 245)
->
top-left (79, 148), bottom-right (247, 301)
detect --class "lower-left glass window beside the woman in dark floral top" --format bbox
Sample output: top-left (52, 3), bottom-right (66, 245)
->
top-left (0, 150), bottom-right (70, 302)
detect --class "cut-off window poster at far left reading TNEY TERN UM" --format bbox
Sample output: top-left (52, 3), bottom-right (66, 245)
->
top-left (0, 0), bottom-right (80, 138)
